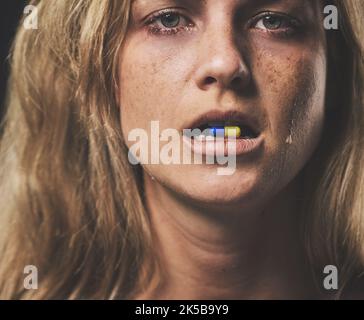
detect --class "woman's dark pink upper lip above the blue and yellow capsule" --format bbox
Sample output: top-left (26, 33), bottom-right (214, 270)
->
top-left (184, 110), bottom-right (263, 135)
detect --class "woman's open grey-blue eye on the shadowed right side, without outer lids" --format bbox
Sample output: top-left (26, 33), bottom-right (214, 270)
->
top-left (254, 14), bottom-right (298, 32)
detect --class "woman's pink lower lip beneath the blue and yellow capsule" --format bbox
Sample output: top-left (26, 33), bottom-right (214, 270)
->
top-left (183, 135), bottom-right (264, 156)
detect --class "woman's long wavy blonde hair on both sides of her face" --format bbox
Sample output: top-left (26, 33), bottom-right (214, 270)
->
top-left (0, 0), bottom-right (364, 299)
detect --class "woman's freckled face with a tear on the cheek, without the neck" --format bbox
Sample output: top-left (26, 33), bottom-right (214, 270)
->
top-left (119, 0), bottom-right (326, 209)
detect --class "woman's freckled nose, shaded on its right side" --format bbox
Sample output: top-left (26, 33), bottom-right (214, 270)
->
top-left (196, 26), bottom-right (250, 90)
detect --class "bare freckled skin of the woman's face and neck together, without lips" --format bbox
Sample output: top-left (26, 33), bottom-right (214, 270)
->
top-left (119, 0), bottom-right (327, 299)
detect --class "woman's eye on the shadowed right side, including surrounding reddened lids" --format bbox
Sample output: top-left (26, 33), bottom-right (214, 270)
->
top-left (250, 12), bottom-right (302, 36)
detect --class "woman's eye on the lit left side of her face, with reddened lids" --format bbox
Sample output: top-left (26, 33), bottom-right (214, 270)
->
top-left (146, 9), bottom-right (193, 35)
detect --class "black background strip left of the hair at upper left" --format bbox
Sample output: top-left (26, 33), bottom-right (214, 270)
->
top-left (0, 0), bottom-right (28, 119)
